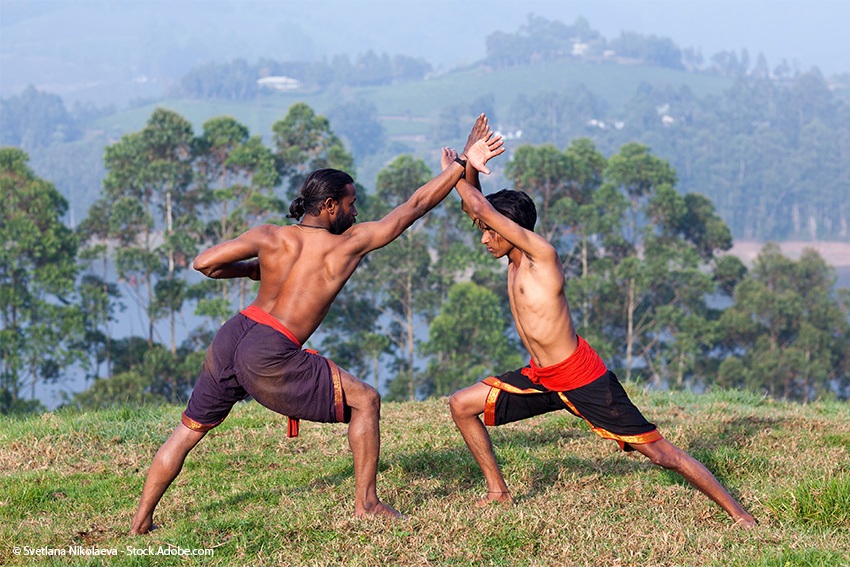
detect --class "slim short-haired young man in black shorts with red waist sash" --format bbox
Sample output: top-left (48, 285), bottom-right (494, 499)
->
top-left (441, 148), bottom-right (756, 527)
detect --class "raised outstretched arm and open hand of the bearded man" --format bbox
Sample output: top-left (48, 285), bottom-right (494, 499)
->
top-left (346, 114), bottom-right (505, 254)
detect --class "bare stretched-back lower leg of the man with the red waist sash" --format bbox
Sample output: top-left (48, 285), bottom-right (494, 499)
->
top-left (632, 439), bottom-right (756, 528)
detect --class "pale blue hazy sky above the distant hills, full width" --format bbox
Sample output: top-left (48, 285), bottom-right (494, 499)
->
top-left (0, 0), bottom-right (850, 101)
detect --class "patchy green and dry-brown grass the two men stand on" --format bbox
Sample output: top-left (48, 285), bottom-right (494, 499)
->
top-left (0, 387), bottom-right (850, 567)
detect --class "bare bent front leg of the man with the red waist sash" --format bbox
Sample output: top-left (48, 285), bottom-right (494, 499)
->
top-left (449, 382), bottom-right (513, 504)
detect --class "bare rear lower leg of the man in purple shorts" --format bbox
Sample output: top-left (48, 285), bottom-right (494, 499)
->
top-left (130, 423), bottom-right (206, 535)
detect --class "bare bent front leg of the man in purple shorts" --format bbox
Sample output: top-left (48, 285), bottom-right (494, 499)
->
top-left (339, 368), bottom-right (401, 518)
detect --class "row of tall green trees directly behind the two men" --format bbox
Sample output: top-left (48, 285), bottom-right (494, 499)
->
top-left (0, 100), bottom-right (850, 412)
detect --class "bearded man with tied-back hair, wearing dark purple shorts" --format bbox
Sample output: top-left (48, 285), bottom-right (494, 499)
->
top-left (130, 114), bottom-right (504, 534)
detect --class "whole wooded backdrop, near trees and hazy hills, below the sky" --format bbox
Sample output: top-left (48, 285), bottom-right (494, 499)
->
top-left (0, 13), bottom-right (850, 411)
